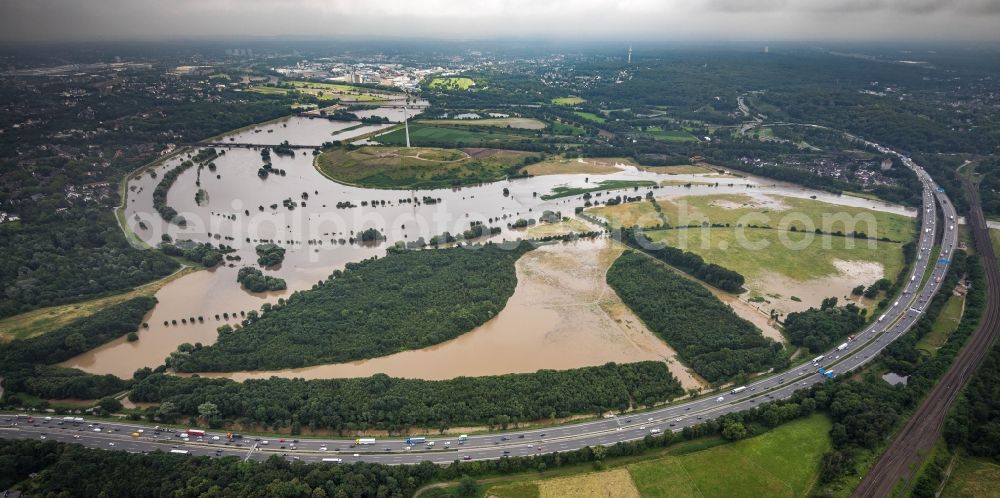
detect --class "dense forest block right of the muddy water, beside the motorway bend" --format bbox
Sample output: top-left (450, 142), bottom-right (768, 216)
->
top-left (607, 251), bottom-right (788, 383)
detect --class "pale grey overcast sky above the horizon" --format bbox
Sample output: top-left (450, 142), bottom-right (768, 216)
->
top-left (0, 0), bottom-right (1000, 41)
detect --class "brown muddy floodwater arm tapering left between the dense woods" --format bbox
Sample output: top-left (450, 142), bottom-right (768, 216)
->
top-left (191, 239), bottom-right (703, 388)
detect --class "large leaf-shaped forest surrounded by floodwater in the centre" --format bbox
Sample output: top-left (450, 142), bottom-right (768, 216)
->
top-left (168, 244), bottom-right (531, 372)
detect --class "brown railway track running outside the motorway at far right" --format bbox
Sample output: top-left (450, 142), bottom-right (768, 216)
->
top-left (853, 176), bottom-right (1000, 498)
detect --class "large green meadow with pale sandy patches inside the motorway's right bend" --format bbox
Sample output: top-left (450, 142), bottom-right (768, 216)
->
top-left (587, 194), bottom-right (916, 313)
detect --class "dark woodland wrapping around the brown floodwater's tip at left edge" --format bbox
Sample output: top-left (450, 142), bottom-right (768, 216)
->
top-left (0, 297), bottom-right (156, 405)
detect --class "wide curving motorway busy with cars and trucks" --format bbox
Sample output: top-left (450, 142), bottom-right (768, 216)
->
top-left (0, 139), bottom-right (957, 464)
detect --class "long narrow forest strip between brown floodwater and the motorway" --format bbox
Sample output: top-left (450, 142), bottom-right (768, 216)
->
top-left (129, 361), bottom-right (684, 432)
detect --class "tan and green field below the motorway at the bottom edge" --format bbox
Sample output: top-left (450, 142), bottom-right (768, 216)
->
top-left (480, 415), bottom-right (832, 498)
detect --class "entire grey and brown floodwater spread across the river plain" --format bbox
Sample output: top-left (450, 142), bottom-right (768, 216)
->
top-left (63, 118), bottom-right (914, 386)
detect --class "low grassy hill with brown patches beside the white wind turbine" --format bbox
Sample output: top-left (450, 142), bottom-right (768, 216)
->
top-left (315, 147), bottom-right (529, 188)
